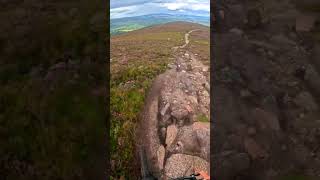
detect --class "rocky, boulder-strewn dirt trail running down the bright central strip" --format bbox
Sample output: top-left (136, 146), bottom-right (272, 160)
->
top-left (138, 29), bottom-right (210, 179)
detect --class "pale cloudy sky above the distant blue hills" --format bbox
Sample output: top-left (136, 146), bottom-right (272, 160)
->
top-left (110, 0), bottom-right (210, 19)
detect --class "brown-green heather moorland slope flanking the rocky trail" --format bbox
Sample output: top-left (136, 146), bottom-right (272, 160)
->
top-left (110, 22), bottom-right (209, 177)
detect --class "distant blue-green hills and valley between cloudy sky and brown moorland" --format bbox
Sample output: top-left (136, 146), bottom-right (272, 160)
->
top-left (110, 14), bottom-right (210, 35)
